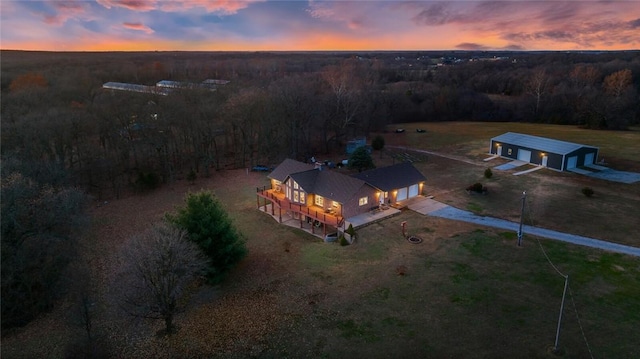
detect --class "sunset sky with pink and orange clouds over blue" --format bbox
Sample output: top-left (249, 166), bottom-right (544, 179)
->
top-left (0, 0), bottom-right (640, 51)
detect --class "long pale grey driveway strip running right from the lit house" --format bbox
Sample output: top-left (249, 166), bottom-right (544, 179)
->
top-left (428, 206), bottom-right (640, 257)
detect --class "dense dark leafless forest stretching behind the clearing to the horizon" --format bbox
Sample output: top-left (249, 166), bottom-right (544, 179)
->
top-left (1, 51), bottom-right (640, 329)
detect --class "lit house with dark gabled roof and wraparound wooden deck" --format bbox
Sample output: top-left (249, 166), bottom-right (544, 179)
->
top-left (257, 159), bottom-right (425, 234)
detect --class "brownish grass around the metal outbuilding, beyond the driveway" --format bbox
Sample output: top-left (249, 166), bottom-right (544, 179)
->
top-left (376, 123), bottom-right (640, 247)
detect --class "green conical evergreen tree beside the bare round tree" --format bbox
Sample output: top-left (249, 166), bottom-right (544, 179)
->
top-left (166, 191), bottom-right (247, 284)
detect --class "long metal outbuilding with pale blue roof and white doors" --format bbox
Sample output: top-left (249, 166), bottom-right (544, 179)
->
top-left (489, 132), bottom-right (598, 171)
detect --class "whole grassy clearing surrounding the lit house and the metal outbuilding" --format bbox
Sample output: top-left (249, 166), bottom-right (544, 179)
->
top-left (2, 123), bottom-right (640, 358)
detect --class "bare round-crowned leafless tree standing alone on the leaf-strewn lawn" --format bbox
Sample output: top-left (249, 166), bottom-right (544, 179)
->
top-left (115, 224), bottom-right (207, 334)
